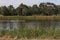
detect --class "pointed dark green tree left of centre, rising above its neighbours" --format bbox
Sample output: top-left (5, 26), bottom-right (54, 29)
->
top-left (16, 3), bottom-right (28, 15)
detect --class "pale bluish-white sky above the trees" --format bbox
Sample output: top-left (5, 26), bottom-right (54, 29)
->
top-left (0, 0), bottom-right (60, 7)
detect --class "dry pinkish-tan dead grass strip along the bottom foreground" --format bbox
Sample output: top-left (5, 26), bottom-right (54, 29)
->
top-left (0, 35), bottom-right (60, 40)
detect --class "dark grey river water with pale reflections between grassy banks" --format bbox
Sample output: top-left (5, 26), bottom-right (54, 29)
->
top-left (0, 20), bottom-right (60, 29)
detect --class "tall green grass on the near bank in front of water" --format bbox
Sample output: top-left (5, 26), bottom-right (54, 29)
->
top-left (0, 27), bottom-right (60, 39)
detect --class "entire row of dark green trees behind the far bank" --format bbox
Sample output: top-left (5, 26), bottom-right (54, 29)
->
top-left (0, 2), bottom-right (60, 16)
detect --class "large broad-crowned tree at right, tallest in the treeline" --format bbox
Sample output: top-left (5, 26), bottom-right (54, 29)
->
top-left (39, 2), bottom-right (57, 15)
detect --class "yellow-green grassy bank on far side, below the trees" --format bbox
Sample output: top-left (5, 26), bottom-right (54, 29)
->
top-left (0, 16), bottom-right (60, 21)
